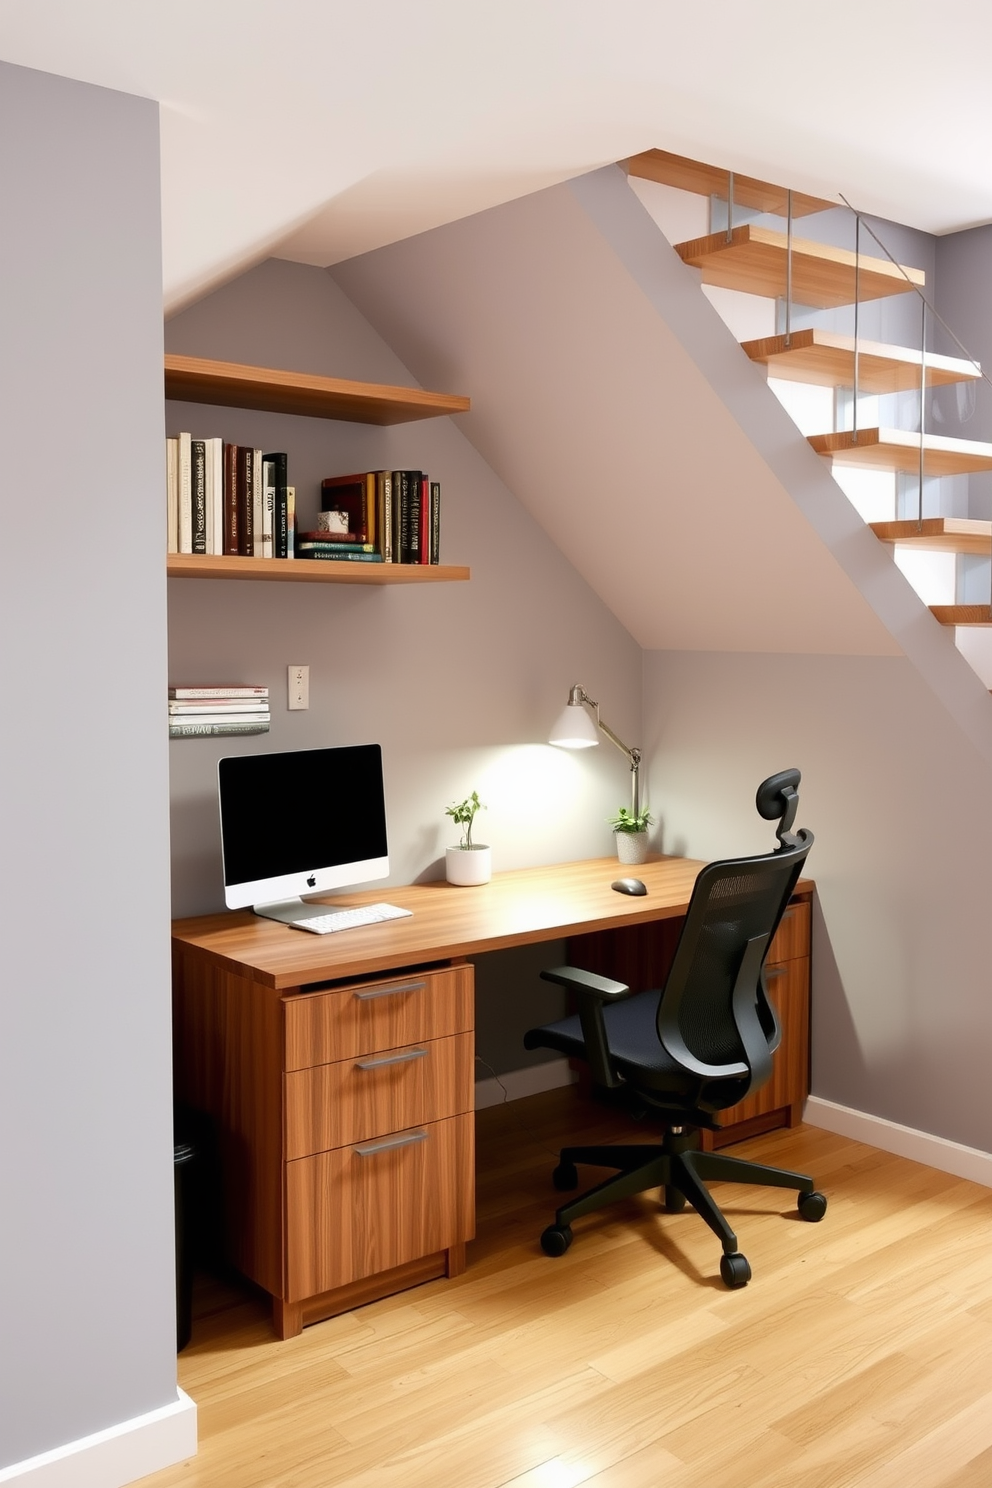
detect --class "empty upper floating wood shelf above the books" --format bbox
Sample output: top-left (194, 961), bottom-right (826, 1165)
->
top-left (165, 354), bottom-right (471, 424)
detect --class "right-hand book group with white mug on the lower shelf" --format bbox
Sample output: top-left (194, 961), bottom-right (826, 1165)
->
top-left (304, 470), bottom-right (440, 564)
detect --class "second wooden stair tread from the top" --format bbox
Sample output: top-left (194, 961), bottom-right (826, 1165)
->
top-left (675, 226), bottom-right (927, 310)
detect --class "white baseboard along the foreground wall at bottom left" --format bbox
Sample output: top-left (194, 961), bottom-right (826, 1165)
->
top-left (0, 1390), bottom-right (196, 1488)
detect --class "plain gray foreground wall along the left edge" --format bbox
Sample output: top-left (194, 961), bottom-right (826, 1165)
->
top-left (0, 64), bottom-right (175, 1467)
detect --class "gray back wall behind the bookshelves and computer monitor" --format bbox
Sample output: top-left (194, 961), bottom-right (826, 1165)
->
top-left (167, 260), bottom-right (641, 1071)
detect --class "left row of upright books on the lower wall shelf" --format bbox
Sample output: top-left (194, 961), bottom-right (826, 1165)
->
top-left (165, 434), bottom-right (296, 558)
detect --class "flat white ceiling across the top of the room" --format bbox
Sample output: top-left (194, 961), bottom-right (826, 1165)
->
top-left (0, 0), bottom-right (992, 308)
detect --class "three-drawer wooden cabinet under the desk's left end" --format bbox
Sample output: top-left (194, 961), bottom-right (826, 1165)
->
top-left (174, 945), bottom-right (474, 1338)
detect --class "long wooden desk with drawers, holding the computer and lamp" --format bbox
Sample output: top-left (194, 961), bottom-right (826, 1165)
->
top-left (173, 857), bottom-right (812, 1338)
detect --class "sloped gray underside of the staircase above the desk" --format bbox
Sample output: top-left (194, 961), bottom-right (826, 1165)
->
top-left (330, 167), bottom-right (898, 655)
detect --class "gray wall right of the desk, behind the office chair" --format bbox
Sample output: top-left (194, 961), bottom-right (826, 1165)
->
top-left (644, 652), bottom-right (992, 1152)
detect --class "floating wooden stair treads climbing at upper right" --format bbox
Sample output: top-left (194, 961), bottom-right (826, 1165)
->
top-left (625, 150), bottom-right (992, 651)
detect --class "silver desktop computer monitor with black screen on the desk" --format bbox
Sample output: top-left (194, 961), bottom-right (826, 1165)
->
top-left (217, 744), bottom-right (390, 920)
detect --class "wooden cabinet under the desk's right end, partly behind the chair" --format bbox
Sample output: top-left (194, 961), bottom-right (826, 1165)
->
top-left (568, 894), bottom-right (811, 1150)
